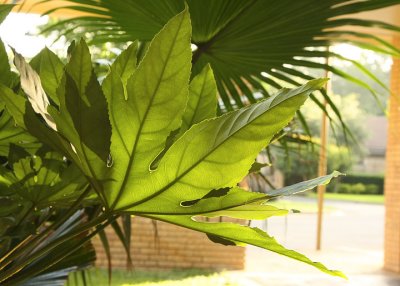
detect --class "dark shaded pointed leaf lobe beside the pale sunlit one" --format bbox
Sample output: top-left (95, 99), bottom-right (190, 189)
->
top-left (49, 40), bottom-right (111, 182)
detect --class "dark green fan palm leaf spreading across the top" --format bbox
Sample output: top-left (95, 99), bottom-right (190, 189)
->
top-left (43, 0), bottom-right (399, 120)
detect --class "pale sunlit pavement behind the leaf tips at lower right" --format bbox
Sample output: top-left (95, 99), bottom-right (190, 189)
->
top-left (232, 197), bottom-right (400, 286)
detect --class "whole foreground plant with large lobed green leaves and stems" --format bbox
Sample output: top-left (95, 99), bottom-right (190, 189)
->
top-left (0, 8), bottom-right (350, 285)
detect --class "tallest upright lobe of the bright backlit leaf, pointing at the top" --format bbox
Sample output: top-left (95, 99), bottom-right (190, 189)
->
top-left (101, 7), bottom-right (191, 208)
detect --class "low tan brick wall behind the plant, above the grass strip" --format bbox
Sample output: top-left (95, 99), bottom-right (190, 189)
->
top-left (93, 217), bottom-right (245, 270)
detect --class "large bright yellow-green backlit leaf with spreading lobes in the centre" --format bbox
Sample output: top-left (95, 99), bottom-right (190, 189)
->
top-left (96, 11), bottom-right (342, 276)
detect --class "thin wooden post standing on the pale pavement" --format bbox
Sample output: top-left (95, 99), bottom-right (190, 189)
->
top-left (317, 55), bottom-right (331, 250)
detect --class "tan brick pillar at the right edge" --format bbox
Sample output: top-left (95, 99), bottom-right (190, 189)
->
top-left (384, 37), bottom-right (400, 272)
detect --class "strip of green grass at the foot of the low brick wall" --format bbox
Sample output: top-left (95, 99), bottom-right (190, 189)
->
top-left (66, 269), bottom-right (237, 286)
